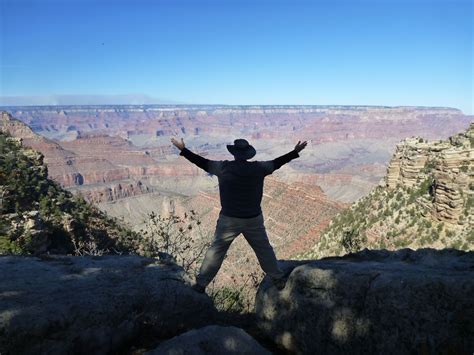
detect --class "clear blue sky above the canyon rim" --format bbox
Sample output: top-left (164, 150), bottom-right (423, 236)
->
top-left (0, 0), bottom-right (474, 114)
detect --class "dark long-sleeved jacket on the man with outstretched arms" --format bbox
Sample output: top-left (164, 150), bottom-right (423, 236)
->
top-left (180, 148), bottom-right (299, 218)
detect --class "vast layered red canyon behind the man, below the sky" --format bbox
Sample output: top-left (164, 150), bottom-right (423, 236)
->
top-left (1, 105), bottom-right (472, 282)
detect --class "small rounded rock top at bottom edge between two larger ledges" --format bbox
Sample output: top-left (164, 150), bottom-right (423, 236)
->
top-left (146, 325), bottom-right (271, 355)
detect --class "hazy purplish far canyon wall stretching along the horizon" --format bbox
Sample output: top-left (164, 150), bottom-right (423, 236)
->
top-left (8, 106), bottom-right (470, 147)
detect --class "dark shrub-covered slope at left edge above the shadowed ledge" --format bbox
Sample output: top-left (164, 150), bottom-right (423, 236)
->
top-left (0, 132), bottom-right (138, 254)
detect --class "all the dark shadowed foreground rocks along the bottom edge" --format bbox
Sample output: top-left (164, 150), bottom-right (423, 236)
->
top-left (0, 249), bottom-right (474, 355)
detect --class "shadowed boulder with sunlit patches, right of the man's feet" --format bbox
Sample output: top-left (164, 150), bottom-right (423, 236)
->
top-left (256, 249), bottom-right (474, 354)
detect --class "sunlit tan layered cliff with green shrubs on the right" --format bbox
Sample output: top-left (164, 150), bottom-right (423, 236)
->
top-left (302, 123), bottom-right (474, 257)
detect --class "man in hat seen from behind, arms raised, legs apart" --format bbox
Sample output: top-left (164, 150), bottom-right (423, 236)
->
top-left (171, 138), bottom-right (307, 292)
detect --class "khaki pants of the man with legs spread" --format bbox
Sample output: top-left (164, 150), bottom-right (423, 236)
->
top-left (196, 214), bottom-right (283, 287)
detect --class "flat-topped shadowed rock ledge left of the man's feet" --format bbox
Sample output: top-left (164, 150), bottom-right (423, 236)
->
top-left (0, 256), bottom-right (215, 354)
